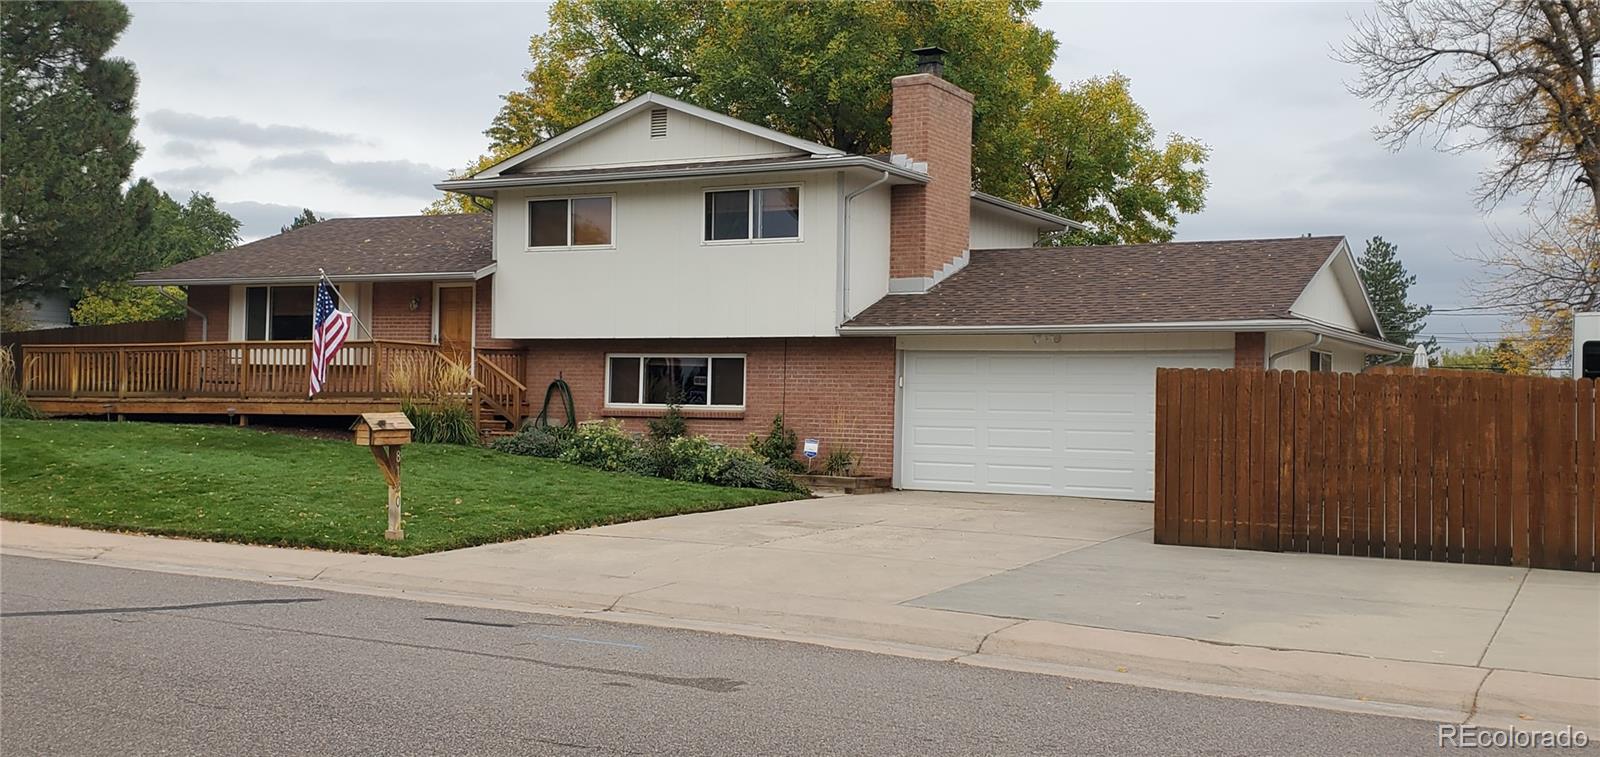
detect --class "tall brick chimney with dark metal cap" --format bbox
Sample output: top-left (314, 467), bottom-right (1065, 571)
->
top-left (890, 48), bottom-right (973, 293)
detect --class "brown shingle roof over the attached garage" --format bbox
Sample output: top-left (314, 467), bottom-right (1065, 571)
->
top-left (845, 237), bottom-right (1344, 328)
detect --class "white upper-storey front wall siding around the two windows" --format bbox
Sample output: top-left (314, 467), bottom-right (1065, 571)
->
top-left (493, 171), bottom-right (864, 339)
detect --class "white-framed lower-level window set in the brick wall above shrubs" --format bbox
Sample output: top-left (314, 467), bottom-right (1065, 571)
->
top-left (605, 355), bottom-right (744, 408)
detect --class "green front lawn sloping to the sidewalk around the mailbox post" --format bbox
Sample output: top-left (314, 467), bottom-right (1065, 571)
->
top-left (0, 419), bottom-right (795, 555)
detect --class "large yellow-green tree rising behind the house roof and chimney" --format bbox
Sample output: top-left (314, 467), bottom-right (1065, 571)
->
top-left (444, 0), bottom-right (1205, 242)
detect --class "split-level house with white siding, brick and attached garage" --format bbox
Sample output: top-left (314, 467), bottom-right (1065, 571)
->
top-left (25, 45), bottom-right (1403, 499)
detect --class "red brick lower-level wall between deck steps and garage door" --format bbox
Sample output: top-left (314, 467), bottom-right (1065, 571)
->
top-left (525, 338), bottom-right (894, 475)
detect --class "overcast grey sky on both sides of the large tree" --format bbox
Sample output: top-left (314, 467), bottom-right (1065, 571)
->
top-left (115, 2), bottom-right (1522, 346)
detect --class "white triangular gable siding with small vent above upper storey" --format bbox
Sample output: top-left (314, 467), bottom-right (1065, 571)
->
top-left (518, 107), bottom-right (800, 171)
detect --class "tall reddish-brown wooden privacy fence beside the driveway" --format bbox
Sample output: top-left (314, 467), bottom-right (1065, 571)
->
top-left (1155, 368), bottom-right (1600, 571)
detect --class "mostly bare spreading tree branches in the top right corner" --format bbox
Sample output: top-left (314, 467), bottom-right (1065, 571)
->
top-left (1339, 0), bottom-right (1600, 211)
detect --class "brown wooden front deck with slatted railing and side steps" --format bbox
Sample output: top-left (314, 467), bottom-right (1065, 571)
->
top-left (19, 339), bottom-right (528, 431)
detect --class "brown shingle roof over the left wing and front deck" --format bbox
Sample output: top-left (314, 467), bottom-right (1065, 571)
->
top-left (134, 213), bottom-right (494, 283)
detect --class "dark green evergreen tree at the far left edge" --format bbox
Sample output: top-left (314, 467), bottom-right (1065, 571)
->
top-left (0, 0), bottom-right (157, 299)
